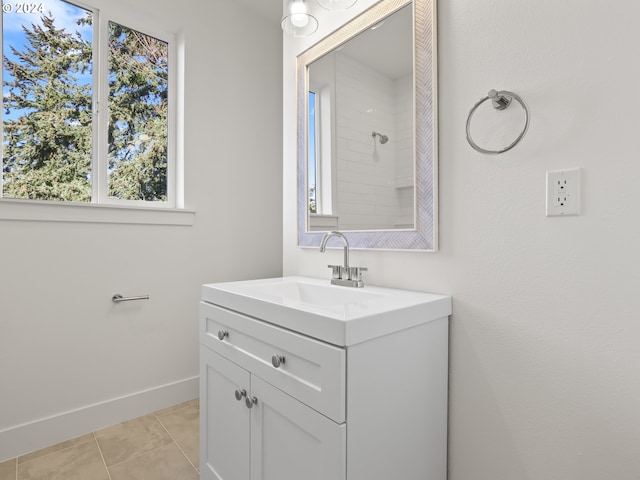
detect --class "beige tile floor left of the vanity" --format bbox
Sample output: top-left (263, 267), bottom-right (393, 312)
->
top-left (0, 399), bottom-right (199, 480)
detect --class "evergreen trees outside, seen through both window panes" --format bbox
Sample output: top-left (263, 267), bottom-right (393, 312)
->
top-left (3, 13), bottom-right (168, 202)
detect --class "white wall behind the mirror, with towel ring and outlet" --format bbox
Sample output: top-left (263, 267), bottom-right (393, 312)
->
top-left (284, 0), bottom-right (640, 480)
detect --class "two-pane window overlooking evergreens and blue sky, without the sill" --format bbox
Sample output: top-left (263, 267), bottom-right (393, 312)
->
top-left (0, 0), bottom-right (177, 208)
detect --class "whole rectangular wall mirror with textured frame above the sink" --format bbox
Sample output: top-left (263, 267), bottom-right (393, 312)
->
top-left (297, 0), bottom-right (437, 250)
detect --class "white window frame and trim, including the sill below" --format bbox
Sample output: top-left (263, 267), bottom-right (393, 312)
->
top-left (0, 0), bottom-right (190, 225)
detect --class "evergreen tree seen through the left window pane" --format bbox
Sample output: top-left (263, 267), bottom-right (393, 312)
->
top-left (2, 15), bottom-right (92, 202)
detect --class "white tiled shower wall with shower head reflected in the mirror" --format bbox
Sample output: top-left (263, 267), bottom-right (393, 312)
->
top-left (335, 53), bottom-right (414, 230)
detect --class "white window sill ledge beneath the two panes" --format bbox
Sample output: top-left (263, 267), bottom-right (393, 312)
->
top-left (0, 199), bottom-right (196, 226)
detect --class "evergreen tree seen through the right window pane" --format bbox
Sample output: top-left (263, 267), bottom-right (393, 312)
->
top-left (108, 22), bottom-right (168, 201)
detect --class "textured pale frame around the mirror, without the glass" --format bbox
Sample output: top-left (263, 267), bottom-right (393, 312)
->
top-left (296, 0), bottom-right (438, 251)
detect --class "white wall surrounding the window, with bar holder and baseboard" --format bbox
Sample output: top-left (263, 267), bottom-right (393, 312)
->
top-left (0, 0), bottom-right (282, 461)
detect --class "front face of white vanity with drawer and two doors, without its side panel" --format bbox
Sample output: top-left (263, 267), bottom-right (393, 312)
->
top-left (200, 303), bottom-right (346, 480)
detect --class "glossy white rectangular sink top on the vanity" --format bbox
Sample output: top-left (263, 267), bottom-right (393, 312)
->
top-left (202, 277), bottom-right (451, 346)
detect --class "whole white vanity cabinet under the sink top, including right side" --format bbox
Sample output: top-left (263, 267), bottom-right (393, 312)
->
top-left (200, 278), bottom-right (451, 480)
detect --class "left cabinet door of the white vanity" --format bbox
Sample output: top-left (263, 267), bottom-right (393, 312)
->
top-left (200, 347), bottom-right (251, 480)
